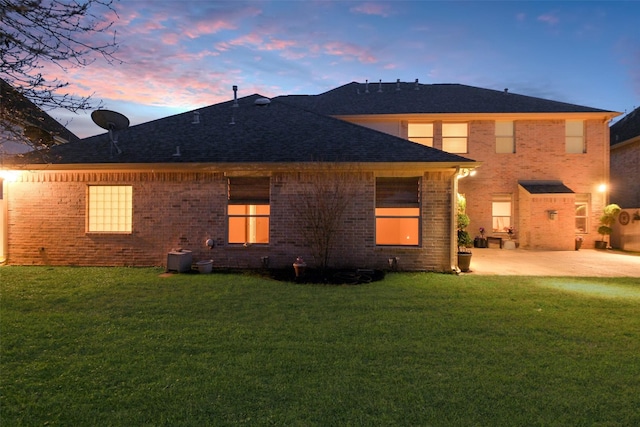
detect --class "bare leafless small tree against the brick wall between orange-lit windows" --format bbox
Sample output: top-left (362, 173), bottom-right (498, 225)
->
top-left (290, 167), bottom-right (355, 274)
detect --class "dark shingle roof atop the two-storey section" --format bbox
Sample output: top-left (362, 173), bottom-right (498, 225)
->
top-left (278, 82), bottom-right (608, 116)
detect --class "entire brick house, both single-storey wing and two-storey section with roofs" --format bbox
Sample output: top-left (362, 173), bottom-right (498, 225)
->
top-left (0, 81), bottom-right (618, 271)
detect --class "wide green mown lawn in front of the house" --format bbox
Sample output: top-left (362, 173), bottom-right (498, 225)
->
top-left (0, 267), bottom-right (640, 426)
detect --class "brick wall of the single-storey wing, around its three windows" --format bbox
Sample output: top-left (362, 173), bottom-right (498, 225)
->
top-left (5, 168), bottom-right (452, 271)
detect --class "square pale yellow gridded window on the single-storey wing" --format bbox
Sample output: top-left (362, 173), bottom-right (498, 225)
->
top-left (87, 185), bottom-right (133, 233)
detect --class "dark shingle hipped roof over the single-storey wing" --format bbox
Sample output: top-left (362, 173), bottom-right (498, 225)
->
top-left (23, 94), bottom-right (473, 164)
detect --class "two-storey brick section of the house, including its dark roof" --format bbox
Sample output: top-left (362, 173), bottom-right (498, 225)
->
top-left (284, 80), bottom-right (619, 250)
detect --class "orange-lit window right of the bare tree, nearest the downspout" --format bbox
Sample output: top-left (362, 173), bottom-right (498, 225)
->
top-left (376, 177), bottom-right (420, 246)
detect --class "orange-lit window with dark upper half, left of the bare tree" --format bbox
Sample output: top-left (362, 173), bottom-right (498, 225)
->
top-left (227, 177), bottom-right (271, 244)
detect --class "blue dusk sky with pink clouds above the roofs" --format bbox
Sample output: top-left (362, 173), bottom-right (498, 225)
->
top-left (43, 0), bottom-right (640, 138)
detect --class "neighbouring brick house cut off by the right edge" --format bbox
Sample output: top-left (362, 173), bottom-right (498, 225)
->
top-left (610, 107), bottom-right (640, 208)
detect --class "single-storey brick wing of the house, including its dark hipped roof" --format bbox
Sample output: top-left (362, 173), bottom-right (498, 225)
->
top-left (4, 90), bottom-right (478, 271)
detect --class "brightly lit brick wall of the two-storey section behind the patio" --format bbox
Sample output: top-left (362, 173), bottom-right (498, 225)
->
top-left (459, 120), bottom-right (609, 250)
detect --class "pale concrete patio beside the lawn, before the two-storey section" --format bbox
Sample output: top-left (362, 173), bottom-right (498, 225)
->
top-left (466, 248), bottom-right (640, 278)
